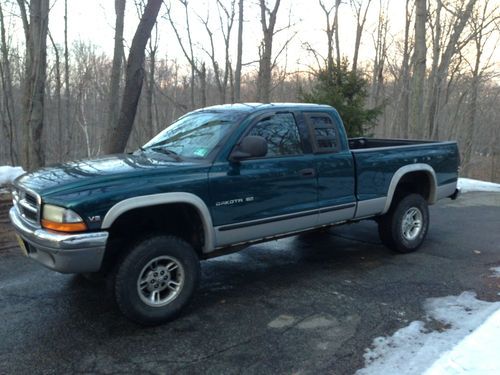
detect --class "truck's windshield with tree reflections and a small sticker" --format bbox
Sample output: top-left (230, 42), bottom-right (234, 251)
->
top-left (142, 112), bottom-right (242, 159)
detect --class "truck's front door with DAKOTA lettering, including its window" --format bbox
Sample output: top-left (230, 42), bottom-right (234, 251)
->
top-left (209, 112), bottom-right (318, 246)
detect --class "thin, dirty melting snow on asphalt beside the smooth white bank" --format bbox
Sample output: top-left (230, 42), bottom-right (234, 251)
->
top-left (356, 292), bottom-right (500, 375)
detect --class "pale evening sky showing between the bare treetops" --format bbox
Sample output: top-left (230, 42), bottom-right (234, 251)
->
top-left (2, 0), bottom-right (500, 80)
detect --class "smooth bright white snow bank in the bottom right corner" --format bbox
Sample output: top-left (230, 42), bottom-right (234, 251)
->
top-left (424, 310), bottom-right (500, 375)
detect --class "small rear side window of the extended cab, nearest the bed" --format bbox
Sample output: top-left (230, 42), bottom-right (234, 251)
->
top-left (305, 113), bottom-right (339, 152)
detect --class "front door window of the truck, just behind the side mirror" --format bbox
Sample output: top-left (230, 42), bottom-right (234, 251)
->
top-left (248, 113), bottom-right (302, 157)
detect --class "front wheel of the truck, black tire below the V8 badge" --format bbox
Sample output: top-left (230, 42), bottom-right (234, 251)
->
top-left (114, 236), bottom-right (200, 325)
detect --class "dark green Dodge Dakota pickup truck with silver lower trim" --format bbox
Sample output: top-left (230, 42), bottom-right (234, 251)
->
top-left (10, 103), bottom-right (459, 325)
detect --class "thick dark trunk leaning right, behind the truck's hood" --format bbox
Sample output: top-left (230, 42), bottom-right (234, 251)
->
top-left (106, 0), bottom-right (162, 153)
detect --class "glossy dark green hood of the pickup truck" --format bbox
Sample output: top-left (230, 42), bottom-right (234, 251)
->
top-left (16, 152), bottom-right (203, 196)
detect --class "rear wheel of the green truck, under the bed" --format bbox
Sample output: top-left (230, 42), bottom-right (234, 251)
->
top-left (378, 194), bottom-right (429, 253)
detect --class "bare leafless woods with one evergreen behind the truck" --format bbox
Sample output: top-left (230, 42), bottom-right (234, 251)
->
top-left (0, 0), bottom-right (500, 182)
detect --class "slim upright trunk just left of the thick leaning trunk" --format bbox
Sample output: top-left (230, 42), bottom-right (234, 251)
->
top-left (104, 0), bottom-right (126, 150)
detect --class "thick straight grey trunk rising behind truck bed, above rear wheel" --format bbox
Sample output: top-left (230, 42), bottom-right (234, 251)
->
top-left (410, 0), bottom-right (427, 138)
